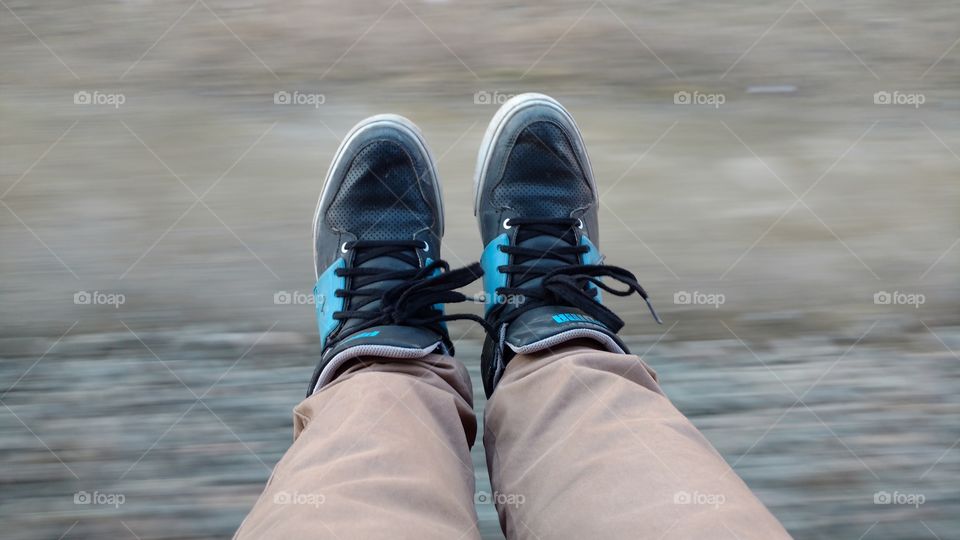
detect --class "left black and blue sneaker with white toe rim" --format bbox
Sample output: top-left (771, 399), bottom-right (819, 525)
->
top-left (307, 115), bottom-right (480, 395)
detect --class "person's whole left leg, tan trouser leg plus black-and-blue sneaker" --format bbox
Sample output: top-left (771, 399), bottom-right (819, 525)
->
top-left (237, 115), bottom-right (488, 539)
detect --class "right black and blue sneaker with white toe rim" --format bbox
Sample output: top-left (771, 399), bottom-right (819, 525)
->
top-left (474, 94), bottom-right (660, 396)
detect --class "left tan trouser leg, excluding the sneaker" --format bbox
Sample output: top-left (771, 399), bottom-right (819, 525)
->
top-left (236, 354), bottom-right (479, 540)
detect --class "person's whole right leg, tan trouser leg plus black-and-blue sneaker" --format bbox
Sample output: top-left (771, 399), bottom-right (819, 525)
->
top-left (475, 94), bottom-right (787, 540)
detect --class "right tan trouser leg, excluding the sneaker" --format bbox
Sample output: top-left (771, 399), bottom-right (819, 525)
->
top-left (484, 342), bottom-right (789, 540)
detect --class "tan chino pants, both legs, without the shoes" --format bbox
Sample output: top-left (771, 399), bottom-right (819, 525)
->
top-left (236, 344), bottom-right (789, 540)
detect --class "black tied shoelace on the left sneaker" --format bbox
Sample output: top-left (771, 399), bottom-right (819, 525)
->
top-left (333, 240), bottom-right (489, 341)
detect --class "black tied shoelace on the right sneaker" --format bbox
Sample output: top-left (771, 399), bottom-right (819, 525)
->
top-left (496, 218), bottom-right (663, 332)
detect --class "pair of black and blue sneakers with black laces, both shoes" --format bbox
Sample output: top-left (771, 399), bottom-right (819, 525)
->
top-left (308, 94), bottom-right (659, 396)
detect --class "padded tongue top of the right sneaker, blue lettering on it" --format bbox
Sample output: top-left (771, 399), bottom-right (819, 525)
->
top-left (504, 306), bottom-right (626, 353)
